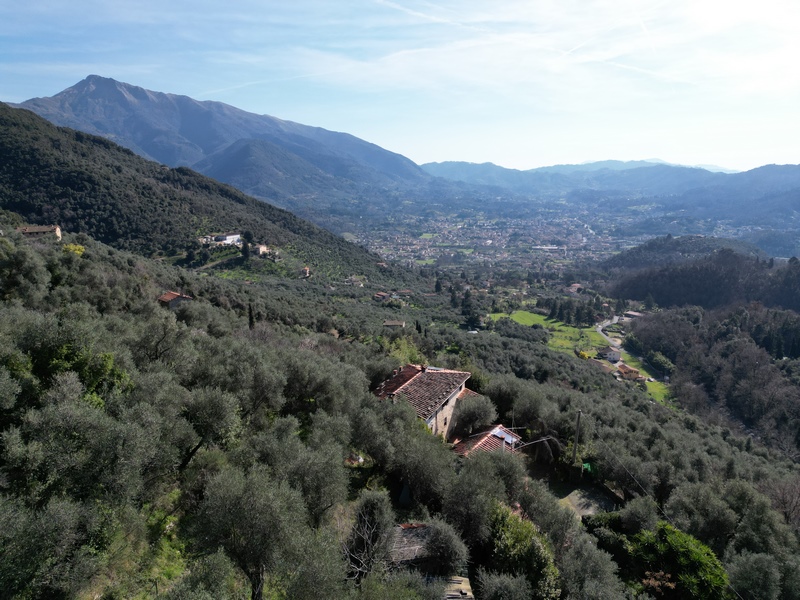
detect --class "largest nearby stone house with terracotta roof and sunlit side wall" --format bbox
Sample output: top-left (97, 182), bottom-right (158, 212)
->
top-left (375, 365), bottom-right (480, 439)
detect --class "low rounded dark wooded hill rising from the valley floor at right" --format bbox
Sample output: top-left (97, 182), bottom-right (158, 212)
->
top-left (601, 235), bottom-right (769, 269)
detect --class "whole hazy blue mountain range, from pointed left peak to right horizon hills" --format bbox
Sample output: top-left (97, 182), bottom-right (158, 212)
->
top-left (9, 75), bottom-right (800, 254)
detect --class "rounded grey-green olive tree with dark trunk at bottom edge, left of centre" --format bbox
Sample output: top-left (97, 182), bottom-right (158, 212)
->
top-left (198, 467), bottom-right (308, 600)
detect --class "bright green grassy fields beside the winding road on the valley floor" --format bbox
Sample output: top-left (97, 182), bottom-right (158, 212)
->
top-left (489, 310), bottom-right (669, 404)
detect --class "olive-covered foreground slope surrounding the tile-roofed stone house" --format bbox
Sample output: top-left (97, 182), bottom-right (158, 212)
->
top-left (0, 227), bottom-right (800, 599)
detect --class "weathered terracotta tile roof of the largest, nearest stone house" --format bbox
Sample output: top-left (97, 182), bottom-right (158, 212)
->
top-left (376, 365), bottom-right (471, 421)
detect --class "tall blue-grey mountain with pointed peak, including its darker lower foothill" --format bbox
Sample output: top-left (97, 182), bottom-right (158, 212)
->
top-left (14, 75), bottom-right (444, 231)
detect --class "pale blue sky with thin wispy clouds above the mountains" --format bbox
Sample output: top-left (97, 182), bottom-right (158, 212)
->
top-left (0, 0), bottom-right (800, 170)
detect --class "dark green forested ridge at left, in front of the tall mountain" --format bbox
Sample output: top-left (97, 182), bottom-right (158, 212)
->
top-left (0, 103), bottom-right (406, 276)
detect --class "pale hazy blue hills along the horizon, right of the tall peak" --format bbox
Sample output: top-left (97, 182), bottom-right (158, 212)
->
top-left (423, 161), bottom-right (800, 238)
